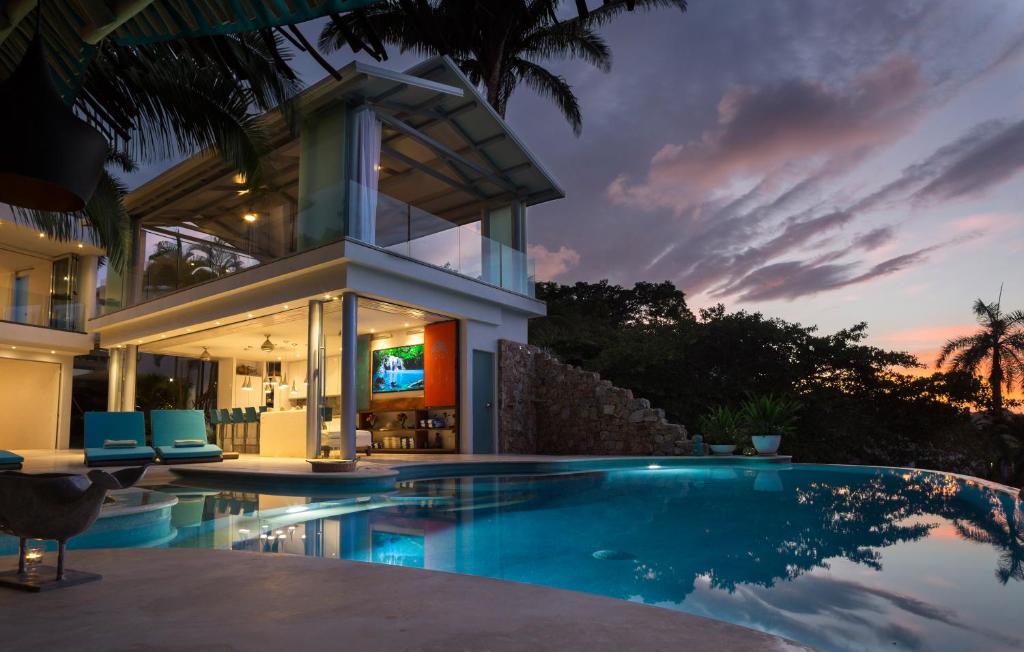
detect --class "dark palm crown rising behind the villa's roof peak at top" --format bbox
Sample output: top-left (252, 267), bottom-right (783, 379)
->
top-left (319, 0), bottom-right (686, 135)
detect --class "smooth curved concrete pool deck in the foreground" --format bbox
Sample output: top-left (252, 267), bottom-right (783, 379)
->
top-left (0, 549), bottom-right (810, 652)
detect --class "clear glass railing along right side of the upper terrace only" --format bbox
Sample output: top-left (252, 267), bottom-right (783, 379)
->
top-left (349, 183), bottom-right (535, 297)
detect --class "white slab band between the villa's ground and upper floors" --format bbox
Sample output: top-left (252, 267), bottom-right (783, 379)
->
top-left (88, 240), bottom-right (546, 348)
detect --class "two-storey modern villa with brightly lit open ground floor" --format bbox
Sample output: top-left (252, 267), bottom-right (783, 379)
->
top-left (3, 58), bottom-right (562, 458)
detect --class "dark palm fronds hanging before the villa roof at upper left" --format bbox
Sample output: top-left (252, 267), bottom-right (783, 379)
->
top-left (15, 31), bottom-right (300, 268)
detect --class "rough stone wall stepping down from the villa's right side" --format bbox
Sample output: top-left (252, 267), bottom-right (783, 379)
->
top-left (498, 340), bottom-right (692, 455)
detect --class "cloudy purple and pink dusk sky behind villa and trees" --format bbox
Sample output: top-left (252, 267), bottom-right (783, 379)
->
top-left (132, 0), bottom-right (1024, 362)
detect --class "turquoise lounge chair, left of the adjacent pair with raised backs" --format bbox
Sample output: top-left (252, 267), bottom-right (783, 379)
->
top-left (85, 412), bottom-right (157, 467)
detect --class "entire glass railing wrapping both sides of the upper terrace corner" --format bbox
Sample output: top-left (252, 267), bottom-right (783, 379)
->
top-left (97, 183), bottom-right (534, 314)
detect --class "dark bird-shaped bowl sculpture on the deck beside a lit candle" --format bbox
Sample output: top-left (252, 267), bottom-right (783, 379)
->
top-left (0, 467), bottom-right (145, 591)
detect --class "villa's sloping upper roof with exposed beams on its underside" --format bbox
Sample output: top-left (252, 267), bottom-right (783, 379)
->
top-left (125, 57), bottom-right (564, 231)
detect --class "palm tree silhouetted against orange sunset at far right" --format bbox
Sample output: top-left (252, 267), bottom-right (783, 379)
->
top-left (935, 299), bottom-right (1024, 419)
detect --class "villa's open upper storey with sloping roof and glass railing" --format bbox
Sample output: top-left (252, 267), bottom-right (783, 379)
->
top-left (100, 58), bottom-right (563, 313)
